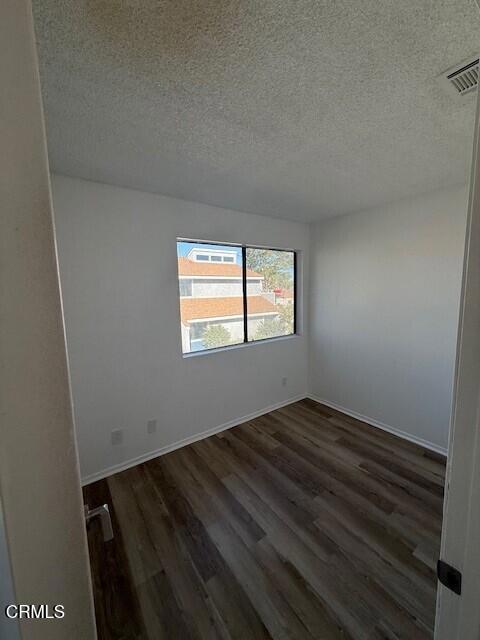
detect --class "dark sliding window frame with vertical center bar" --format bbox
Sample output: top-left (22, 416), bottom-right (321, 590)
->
top-left (176, 238), bottom-right (299, 358)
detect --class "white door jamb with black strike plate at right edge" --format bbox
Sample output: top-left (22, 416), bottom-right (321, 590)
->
top-left (435, 82), bottom-right (480, 640)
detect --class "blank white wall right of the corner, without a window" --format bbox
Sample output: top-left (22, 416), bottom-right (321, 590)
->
top-left (310, 188), bottom-right (468, 450)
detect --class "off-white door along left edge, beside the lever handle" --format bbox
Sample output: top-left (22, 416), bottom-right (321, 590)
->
top-left (0, 0), bottom-right (96, 640)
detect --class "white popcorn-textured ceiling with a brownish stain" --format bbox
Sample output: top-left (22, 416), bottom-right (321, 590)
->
top-left (33, 0), bottom-right (480, 220)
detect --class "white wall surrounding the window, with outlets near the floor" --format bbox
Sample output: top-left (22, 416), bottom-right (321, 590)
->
top-left (53, 176), bottom-right (309, 478)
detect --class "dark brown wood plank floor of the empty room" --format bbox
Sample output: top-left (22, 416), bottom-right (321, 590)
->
top-left (84, 400), bottom-right (445, 640)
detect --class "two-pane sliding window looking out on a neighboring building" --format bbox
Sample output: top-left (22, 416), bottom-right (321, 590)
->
top-left (177, 240), bottom-right (296, 353)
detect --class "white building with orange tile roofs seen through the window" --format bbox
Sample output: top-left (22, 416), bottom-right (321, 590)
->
top-left (178, 248), bottom-right (278, 352)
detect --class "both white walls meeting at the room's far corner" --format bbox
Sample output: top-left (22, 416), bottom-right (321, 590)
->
top-left (53, 176), bottom-right (467, 479)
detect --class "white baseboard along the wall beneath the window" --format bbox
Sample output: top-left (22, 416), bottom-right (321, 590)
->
top-left (82, 394), bottom-right (307, 486)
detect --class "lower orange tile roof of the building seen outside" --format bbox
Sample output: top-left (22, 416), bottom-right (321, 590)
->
top-left (180, 296), bottom-right (278, 324)
